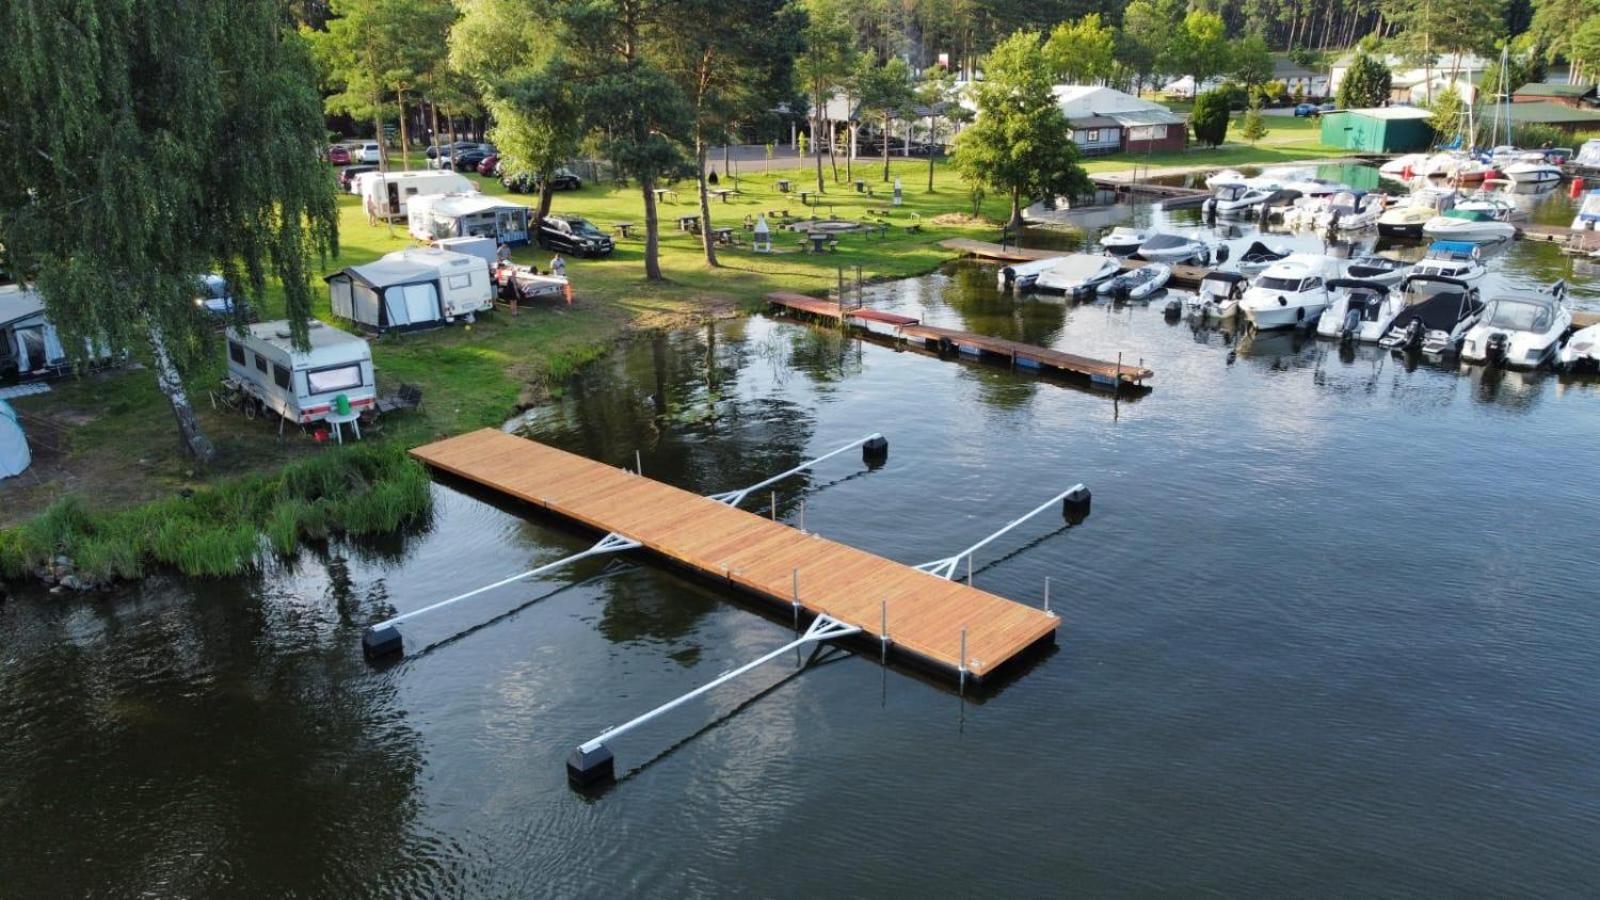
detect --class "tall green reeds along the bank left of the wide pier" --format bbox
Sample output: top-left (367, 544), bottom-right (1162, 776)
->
top-left (0, 444), bottom-right (432, 593)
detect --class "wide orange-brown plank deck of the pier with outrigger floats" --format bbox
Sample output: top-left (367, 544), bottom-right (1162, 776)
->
top-left (411, 429), bottom-right (1061, 679)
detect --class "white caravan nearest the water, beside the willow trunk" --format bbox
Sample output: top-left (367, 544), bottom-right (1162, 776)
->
top-left (227, 319), bottom-right (378, 424)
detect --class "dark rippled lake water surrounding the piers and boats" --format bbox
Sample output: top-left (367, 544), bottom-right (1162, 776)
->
top-left (0, 173), bottom-right (1600, 897)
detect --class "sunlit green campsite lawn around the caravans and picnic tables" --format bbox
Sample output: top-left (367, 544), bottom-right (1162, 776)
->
top-left (0, 129), bottom-right (1338, 528)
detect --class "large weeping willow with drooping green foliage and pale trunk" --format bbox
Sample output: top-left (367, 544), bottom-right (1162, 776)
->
top-left (0, 0), bottom-right (338, 463)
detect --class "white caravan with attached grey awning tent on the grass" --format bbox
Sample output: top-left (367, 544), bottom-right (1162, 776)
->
top-left (326, 248), bottom-right (494, 331)
